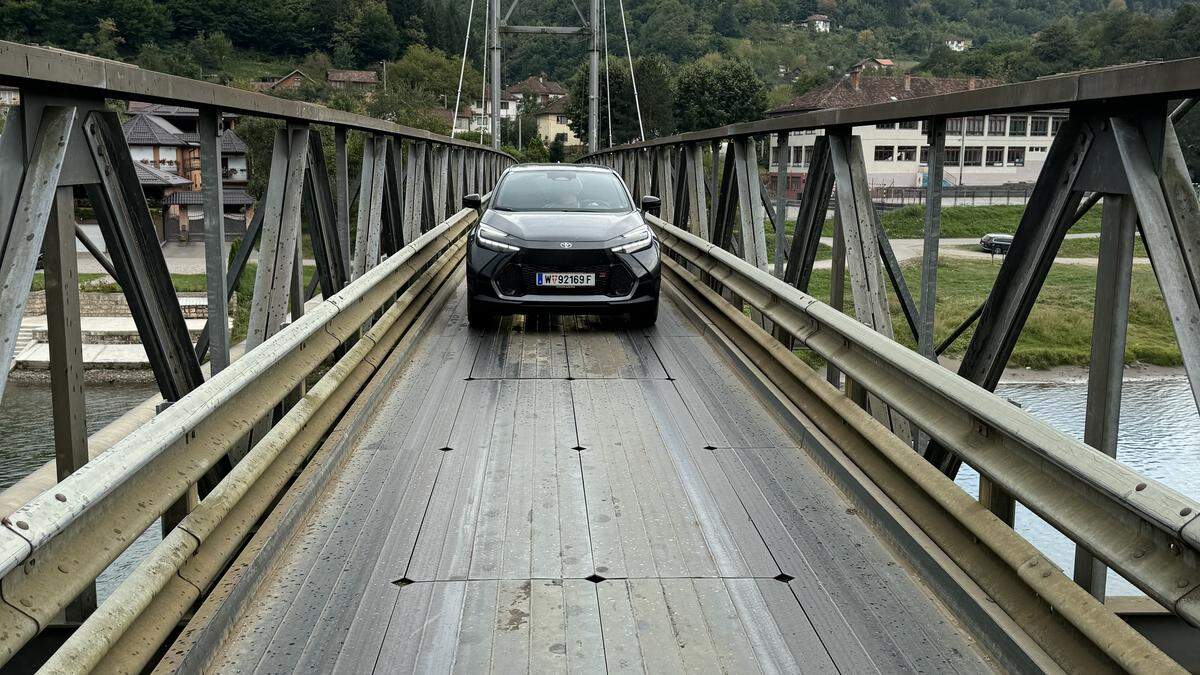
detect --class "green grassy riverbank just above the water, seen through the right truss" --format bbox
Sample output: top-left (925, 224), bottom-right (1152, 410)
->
top-left (809, 258), bottom-right (1182, 369)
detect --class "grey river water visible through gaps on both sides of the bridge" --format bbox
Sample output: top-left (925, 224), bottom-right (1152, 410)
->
top-left (0, 377), bottom-right (1200, 598)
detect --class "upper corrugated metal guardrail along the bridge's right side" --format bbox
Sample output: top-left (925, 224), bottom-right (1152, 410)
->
top-left (647, 216), bottom-right (1200, 626)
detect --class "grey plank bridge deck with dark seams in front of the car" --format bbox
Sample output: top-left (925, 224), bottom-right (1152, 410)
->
top-left (180, 284), bottom-right (994, 673)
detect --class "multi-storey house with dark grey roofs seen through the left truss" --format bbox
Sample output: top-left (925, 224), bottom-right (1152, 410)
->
top-left (121, 101), bottom-right (254, 241)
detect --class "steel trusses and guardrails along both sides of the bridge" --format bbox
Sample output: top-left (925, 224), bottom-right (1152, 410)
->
top-left (0, 43), bottom-right (1200, 671)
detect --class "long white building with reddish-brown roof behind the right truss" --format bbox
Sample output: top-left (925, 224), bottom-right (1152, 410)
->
top-left (768, 73), bottom-right (1067, 199)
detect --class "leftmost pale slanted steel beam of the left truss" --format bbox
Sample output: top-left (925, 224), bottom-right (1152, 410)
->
top-left (0, 107), bottom-right (76, 396)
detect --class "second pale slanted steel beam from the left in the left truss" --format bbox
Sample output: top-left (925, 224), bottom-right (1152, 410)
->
top-left (246, 125), bottom-right (308, 351)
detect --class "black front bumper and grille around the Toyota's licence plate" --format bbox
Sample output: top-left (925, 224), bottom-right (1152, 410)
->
top-left (467, 237), bottom-right (660, 313)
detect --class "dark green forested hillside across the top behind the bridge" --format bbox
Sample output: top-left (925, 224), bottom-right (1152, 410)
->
top-left (0, 0), bottom-right (1200, 149)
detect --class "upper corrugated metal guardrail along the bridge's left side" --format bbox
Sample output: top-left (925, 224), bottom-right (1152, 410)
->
top-left (0, 209), bottom-right (478, 661)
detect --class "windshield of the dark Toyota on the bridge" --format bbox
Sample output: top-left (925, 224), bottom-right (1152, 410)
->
top-left (492, 168), bottom-right (632, 214)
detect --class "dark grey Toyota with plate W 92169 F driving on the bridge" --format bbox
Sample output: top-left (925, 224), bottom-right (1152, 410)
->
top-left (463, 165), bottom-right (660, 327)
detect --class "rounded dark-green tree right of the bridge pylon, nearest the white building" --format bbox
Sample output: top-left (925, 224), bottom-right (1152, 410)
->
top-left (674, 59), bottom-right (767, 131)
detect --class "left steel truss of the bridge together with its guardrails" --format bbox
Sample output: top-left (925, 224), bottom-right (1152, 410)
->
top-left (0, 43), bottom-right (511, 659)
